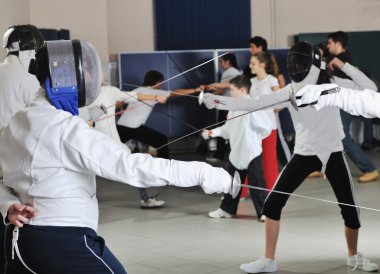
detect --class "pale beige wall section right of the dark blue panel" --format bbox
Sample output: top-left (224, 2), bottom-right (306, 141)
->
top-left (251, 0), bottom-right (380, 48)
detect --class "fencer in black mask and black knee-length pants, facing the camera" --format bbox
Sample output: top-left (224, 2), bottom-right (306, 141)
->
top-left (200, 41), bottom-right (379, 273)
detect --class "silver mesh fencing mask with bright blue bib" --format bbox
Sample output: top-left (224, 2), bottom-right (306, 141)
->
top-left (29, 40), bottom-right (102, 115)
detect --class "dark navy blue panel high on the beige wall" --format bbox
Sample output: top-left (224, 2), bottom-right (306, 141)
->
top-left (154, 0), bottom-right (251, 50)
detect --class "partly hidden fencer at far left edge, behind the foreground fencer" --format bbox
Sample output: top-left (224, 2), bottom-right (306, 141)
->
top-left (0, 25), bottom-right (43, 273)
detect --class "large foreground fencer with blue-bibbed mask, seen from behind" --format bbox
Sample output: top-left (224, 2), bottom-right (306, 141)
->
top-left (0, 40), bottom-right (239, 274)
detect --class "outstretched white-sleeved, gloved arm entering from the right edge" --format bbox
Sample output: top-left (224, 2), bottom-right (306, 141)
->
top-left (297, 84), bottom-right (380, 118)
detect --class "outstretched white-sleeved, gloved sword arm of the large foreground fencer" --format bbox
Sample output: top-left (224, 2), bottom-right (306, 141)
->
top-left (60, 119), bottom-right (240, 197)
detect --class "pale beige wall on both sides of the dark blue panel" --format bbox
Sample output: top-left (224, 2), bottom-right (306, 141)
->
top-left (0, 0), bottom-right (380, 62)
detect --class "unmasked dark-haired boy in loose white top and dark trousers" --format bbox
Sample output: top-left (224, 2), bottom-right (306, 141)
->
top-left (202, 75), bottom-right (273, 220)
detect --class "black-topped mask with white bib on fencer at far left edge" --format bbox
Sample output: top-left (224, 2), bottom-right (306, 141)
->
top-left (3, 25), bottom-right (44, 70)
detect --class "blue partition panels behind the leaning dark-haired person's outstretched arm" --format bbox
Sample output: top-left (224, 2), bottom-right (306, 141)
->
top-left (119, 50), bottom-right (216, 138)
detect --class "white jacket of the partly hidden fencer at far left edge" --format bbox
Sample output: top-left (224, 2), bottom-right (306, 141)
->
top-left (0, 55), bottom-right (40, 128)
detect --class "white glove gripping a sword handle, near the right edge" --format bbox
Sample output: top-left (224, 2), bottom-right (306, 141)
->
top-left (296, 84), bottom-right (340, 110)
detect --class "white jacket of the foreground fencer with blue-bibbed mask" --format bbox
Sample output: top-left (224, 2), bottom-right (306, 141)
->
top-left (0, 89), bottom-right (232, 231)
